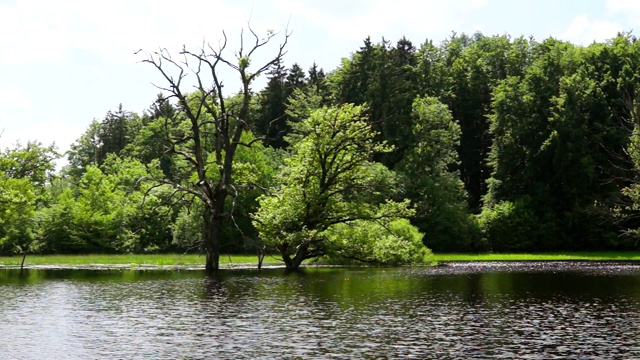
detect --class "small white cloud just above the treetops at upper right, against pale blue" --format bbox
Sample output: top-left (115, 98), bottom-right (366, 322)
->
top-left (559, 15), bottom-right (621, 45)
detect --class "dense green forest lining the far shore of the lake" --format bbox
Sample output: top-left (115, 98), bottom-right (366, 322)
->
top-left (0, 30), bottom-right (640, 268)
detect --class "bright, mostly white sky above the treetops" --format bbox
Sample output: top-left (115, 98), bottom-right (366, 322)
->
top-left (0, 0), bottom-right (640, 164)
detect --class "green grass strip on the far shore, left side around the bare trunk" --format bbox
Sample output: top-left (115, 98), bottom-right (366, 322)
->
top-left (0, 254), bottom-right (280, 266)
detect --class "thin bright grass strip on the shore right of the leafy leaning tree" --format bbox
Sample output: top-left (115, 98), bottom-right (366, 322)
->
top-left (434, 251), bottom-right (640, 261)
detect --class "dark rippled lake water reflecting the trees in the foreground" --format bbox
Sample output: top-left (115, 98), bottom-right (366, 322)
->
top-left (0, 263), bottom-right (640, 359)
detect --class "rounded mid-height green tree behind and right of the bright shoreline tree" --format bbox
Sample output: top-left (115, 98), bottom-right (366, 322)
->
top-left (397, 97), bottom-right (479, 251)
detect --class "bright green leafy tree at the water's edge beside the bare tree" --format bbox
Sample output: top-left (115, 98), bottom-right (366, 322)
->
top-left (254, 104), bottom-right (429, 269)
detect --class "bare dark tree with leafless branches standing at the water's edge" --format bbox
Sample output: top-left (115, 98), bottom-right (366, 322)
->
top-left (143, 27), bottom-right (290, 272)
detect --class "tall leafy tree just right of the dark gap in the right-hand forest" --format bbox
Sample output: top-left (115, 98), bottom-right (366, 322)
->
top-left (481, 39), bottom-right (577, 251)
